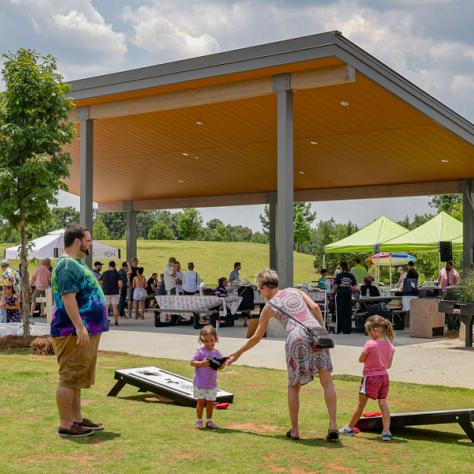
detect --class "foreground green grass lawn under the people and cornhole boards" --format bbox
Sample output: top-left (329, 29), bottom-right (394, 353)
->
top-left (0, 353), bottom-right (474, 474)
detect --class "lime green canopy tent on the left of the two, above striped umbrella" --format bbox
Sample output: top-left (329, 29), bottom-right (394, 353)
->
top-left (324, 216), bottom-right (408, 253)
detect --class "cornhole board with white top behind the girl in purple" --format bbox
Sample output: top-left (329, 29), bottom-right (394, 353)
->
top-left (107, 367), bottom-right (234, 407)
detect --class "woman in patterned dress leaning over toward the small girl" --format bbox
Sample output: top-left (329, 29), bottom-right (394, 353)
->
top-left (228, 269), bottom-right (338, 441)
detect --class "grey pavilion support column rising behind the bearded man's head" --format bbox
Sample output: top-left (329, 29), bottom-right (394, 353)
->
top-left (77, 107), bottom-right (94, 267)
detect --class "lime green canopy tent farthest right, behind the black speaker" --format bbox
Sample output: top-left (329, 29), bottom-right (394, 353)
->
top-left (381, 212), bottom-right (463, 252)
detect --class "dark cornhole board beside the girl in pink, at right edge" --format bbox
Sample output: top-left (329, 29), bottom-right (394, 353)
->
top-left (357, 408), bottom-right (474, 442)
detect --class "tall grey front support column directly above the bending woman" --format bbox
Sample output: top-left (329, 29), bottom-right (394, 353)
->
top-left (273, 74), bottom-right (294, 288)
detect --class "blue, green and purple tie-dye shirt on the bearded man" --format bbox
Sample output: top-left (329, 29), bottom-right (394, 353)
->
top-left (51, 257), bottom-right (109, 337)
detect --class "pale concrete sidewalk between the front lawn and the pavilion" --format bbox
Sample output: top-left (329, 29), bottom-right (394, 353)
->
top-left (100, 317), bottom-right (474, 389)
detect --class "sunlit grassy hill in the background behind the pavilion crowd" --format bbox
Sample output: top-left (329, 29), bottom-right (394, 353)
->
top-left (0, 240), bottom-right (319, 286)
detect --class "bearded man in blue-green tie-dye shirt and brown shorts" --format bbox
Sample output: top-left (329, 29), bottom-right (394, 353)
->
top-left (51, 226), bottom-right (109, 438)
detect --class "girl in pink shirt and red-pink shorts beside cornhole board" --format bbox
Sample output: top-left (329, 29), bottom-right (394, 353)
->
top-left (339, 316), bottom-right (395, 441)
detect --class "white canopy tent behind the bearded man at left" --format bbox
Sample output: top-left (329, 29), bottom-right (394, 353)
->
top-left (5, 229), bottom-right (120, 260)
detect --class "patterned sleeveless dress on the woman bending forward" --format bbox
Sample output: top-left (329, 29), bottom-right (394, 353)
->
top-left (269, 288), bottom-right (332, 387)
